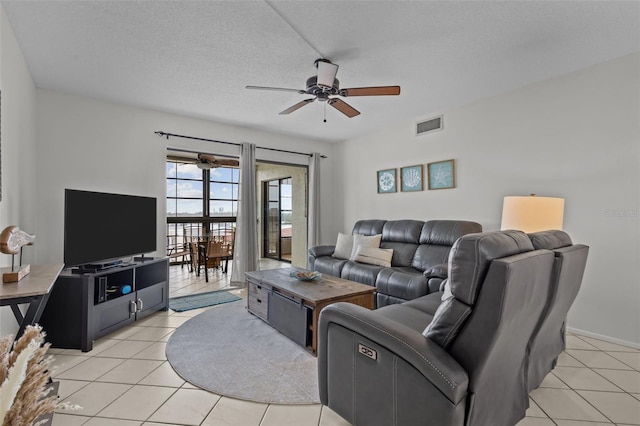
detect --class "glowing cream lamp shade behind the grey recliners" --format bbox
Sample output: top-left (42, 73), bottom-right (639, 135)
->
top-left (500, 195), bottom-right (564, 233)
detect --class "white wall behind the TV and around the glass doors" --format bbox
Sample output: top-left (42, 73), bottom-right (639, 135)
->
top-left (37, 89), bottom-right (333, 268)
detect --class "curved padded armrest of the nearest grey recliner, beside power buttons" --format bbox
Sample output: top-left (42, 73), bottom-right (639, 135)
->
top-left (318, 302), bottom-right (469, 404)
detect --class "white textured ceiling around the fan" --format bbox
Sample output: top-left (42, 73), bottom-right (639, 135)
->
top-left (2, 0), bottom-right (640, 141)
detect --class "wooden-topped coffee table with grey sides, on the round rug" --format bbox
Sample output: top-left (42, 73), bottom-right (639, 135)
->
top-left (246, 268), bottom-right (375, 355)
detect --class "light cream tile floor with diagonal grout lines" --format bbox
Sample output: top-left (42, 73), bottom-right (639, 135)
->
top-left (50, 261), bottom-right (640, 426)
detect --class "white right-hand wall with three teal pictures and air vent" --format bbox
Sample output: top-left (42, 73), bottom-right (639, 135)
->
top-left (333, 54), bottom-right (640, 345)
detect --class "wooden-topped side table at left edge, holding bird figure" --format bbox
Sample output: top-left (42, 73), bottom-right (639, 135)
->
top-left (0, 263), bottom-right (64, 340)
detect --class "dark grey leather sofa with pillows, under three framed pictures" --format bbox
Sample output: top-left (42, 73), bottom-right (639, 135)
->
top-left (309, 219), bottom-right (482, 307)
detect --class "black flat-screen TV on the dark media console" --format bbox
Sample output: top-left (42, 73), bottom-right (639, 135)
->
top-left (64, 189), bottom-right (156, 267)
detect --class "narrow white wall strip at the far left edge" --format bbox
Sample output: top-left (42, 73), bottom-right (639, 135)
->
top-left (0, 5), bottom-right (41, 336)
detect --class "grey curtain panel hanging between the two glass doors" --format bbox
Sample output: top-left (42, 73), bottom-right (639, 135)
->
top-left (231, 142), bottom-right (259, 286)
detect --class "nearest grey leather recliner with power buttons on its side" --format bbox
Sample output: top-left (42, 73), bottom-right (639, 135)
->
top-left (318, 231), bottom-right (554, 426)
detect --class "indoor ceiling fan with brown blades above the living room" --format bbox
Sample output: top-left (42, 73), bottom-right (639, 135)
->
top-left (246, 59), bottom-right (400, 121)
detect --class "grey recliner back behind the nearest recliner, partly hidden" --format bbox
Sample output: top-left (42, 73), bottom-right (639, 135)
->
top-left (528, 231), bottom-right (589, 390)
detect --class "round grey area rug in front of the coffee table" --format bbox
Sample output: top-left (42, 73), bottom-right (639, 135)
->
top-left (166, 300), bottom-right (320, 404)
